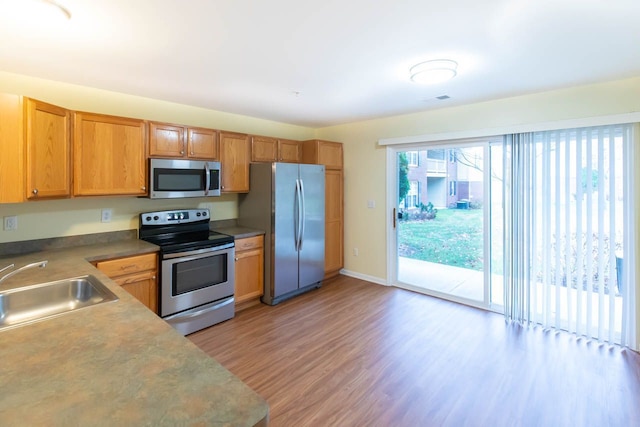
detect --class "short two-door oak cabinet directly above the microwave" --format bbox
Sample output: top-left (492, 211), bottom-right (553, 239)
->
top-left (149, 122), bottom-right (219, 160)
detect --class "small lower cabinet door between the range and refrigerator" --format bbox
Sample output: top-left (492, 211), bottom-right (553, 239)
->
top-left (235, 247), bottom-right (264, 304)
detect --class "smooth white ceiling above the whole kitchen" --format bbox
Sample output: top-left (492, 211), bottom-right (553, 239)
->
top-left (0, 0), bottom-right (640, 127)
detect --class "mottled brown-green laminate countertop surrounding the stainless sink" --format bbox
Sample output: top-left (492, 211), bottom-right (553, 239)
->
top-left (0, 240), bottom-right (269, 426)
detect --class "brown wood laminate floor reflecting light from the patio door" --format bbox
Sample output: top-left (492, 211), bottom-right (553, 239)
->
top-left (189, 276), bottom-right (640, 427)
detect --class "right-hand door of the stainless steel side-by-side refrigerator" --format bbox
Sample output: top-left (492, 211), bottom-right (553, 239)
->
top-left (298, 165), bottom-right (324, 288)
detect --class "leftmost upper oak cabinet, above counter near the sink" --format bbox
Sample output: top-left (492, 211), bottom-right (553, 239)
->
top-left (0, 94), bottom-right (71, 203)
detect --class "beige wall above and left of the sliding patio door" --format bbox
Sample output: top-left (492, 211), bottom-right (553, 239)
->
top-left (317, 78), bottom-right (640, 281)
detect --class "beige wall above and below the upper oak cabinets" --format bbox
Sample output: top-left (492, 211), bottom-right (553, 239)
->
top-left (0, 72), bottom-right (315, 246)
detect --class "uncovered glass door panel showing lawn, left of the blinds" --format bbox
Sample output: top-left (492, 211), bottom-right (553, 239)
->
top-left (395, 141), bottom-right (502, 307)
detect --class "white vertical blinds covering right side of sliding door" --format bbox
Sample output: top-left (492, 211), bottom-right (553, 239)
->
top-left (503, 125), bottom-right (635, 346)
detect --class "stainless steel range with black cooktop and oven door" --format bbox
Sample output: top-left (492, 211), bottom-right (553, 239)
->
top-left (139, 209), bottom-right (235, 335)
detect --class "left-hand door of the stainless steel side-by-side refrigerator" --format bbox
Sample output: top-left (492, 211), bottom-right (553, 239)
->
top-left (272, 163), bottom-right (298, 298)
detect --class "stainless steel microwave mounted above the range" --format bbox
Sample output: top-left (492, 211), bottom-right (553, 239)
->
top-left (149, 159), bottom-right (220, 199)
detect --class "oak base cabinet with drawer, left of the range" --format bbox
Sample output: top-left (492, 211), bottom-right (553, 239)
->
top-left (95, 253), bottom-right (158, 314)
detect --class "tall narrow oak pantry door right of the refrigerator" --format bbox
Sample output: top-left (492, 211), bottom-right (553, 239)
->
top-left (324, 169), bottom-right (344, 277)
